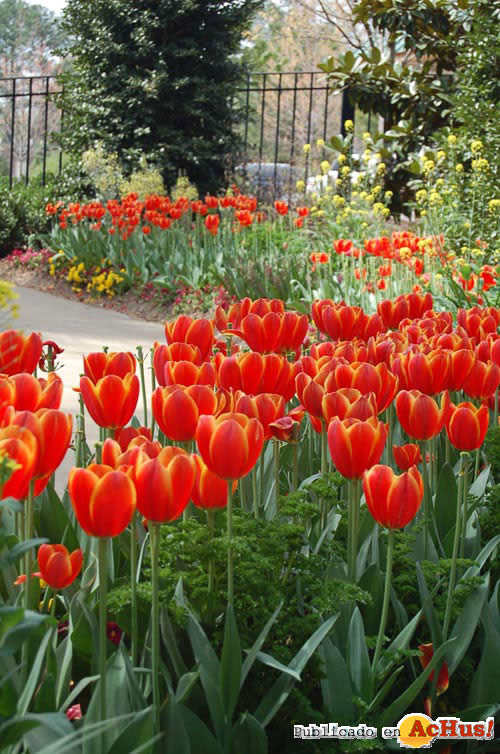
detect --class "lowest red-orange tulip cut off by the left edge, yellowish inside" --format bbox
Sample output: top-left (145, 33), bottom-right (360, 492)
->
top-left (0, 425), bottom-right (38, 500)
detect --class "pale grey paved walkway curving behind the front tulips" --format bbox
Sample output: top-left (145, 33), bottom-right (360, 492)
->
top-left (11, 286), bottom-right (165, 492)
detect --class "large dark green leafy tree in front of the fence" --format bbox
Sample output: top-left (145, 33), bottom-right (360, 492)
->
top-left (57, 0), bottom-right (263, 191)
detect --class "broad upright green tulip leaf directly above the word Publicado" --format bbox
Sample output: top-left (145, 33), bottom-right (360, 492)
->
top-left (319, 636), bottom-right (355, 725)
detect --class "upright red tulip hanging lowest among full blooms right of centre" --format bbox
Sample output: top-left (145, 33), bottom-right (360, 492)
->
top-left (363, 464), bottom-right (424, 529)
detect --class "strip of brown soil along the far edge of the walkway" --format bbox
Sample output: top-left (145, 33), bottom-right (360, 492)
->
top-left (0, 259), bottom-right (173, 322)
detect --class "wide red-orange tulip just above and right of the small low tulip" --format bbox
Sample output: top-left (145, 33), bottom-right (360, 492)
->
top-left (68, 463), bottom-right (136, 537)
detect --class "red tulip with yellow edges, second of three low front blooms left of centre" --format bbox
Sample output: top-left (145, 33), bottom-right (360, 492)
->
top-left (135, 447), bottom-right (196, 523)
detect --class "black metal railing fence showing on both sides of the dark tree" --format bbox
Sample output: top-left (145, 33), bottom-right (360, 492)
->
top-left (0, 71), bottom-right (354, 198)
